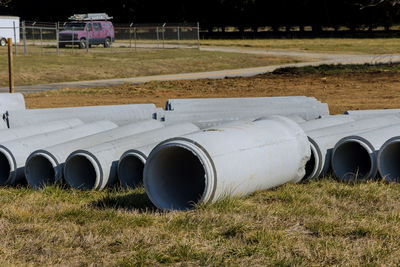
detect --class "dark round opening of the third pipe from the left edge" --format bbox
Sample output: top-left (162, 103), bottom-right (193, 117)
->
top-left (64, 155), bottom-right (97, 190)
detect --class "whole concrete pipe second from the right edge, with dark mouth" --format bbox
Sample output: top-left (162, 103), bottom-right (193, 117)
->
top-left (332, 124), bottom-right (400, 181)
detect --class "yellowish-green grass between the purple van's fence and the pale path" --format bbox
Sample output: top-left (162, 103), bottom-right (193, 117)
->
top-left (0, 48), bottom-right (297, 86)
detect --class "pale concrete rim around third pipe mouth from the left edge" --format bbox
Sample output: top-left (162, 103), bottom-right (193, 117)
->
top-left (63, 150), bottom-right (103, 189)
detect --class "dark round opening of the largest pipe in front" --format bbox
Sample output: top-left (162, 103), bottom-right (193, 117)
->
top-left (145, 146), bottom-right (206, 210)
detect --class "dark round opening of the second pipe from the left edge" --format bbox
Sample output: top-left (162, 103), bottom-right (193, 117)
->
top-left (25, 155), bottom-right (56, 188)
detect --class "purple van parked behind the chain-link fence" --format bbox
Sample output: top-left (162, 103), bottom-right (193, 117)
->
top-left (58, 20), bottom-right (115, 48)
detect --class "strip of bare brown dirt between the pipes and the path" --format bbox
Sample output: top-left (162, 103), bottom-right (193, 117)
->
top-left (25, 71), bottom-right (400, 114)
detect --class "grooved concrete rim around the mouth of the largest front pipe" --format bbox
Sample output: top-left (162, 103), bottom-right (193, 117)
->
top-left (143, 137), bottom-right (217, 210)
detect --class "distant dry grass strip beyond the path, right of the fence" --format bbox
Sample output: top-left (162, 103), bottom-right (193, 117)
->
top-left (201, 38), bottom-right (400, 54)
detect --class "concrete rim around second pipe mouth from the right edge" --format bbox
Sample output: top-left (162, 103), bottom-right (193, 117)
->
top-left (330, 135), bottom-right (378, 180)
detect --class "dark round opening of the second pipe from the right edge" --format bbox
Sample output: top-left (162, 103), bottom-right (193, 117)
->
top-left (332, 142), bottom-right (372, 182)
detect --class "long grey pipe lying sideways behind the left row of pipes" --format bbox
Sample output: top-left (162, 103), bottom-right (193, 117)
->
top-left (4, 104), bottom-right (156, 128)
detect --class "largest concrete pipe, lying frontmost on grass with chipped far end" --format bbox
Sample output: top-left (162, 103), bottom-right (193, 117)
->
top-left (143, 116), bottom-right (310, 210)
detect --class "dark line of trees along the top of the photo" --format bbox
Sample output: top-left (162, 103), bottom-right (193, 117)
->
top-left (0, 0), bottom-right (400, 32)
